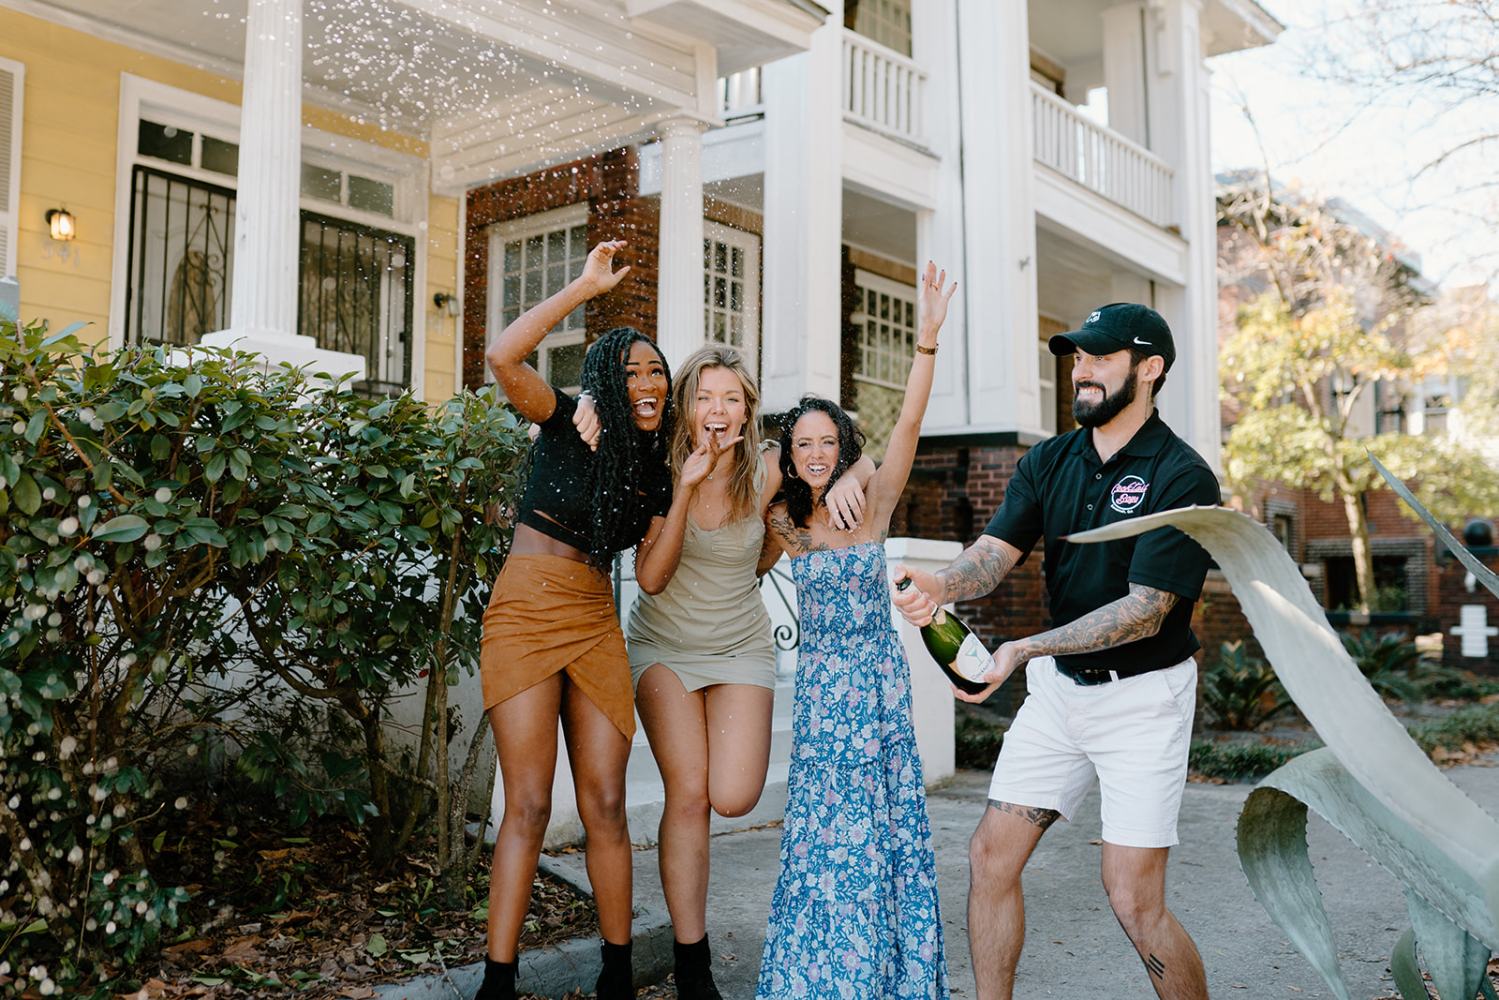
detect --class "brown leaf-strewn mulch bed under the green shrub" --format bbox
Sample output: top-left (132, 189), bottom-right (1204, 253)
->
top-left (108, 816), bottom-right (598, 1000)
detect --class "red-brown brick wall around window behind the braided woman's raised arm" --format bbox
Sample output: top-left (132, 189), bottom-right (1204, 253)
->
top-left (463, 148), bottom-right (660, 387)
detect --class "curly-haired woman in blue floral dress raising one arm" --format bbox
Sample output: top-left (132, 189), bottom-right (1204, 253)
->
top-left (755, 264), bottom-right (956, 1000)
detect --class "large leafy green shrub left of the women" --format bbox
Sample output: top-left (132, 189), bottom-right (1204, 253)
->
top-left (0, 324), bottom-right (525, 993)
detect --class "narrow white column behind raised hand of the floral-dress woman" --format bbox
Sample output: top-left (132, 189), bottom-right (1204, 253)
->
top-left (911, 0), bottom-right (970, 433)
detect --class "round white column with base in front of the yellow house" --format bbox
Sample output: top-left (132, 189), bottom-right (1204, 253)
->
top-left (202, 0), bottom-right (364, 378)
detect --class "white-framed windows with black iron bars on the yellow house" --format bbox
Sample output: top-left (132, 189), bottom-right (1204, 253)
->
top-left (111, 75), bottom-right (420, 396)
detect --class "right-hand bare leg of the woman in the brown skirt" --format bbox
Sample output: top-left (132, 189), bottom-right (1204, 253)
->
top-left (562, 684), bottom-right (631, 945)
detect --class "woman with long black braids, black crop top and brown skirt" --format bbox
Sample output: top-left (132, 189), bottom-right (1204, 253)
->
top-left (475, 241), bottom-right (738, 1000)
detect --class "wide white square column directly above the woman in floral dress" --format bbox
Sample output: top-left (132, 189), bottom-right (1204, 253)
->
top-left (760, 0), bottom-right (844, 412)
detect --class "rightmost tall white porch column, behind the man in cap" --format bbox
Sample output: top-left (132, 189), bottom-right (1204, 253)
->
top-left (1145, 0), bottom-right (1222, 469)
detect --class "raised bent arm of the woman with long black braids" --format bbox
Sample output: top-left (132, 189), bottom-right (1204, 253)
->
top-left (484, 240), bottom-right (630, 423)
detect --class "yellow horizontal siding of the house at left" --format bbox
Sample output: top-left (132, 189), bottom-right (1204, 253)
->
top-left (0, 7), bottom-right (457, 400)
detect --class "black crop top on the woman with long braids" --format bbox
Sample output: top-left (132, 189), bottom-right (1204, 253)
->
top-left (520, 388), bottom-right (672, 552)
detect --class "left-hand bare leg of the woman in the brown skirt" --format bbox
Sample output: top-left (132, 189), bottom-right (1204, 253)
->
top-left (489, 673), bottom-right (562, 963)
